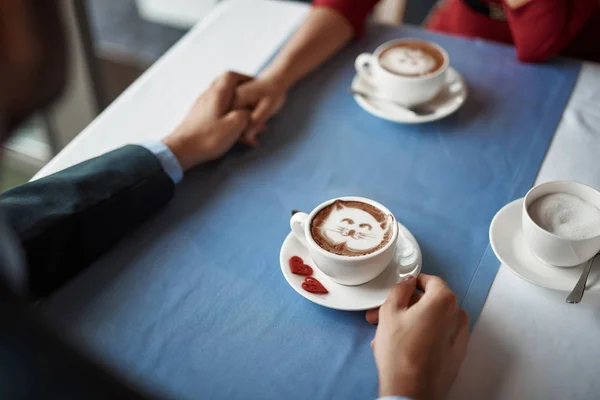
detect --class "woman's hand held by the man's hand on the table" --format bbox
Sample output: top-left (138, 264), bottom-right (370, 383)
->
top-left (233, 77), bottom-right (287, 146)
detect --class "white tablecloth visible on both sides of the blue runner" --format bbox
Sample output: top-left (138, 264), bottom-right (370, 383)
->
top-left (36, 0), bottom-right (600, 400)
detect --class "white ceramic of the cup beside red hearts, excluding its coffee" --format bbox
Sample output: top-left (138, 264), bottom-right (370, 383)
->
top-left (290, 197), bottom-right (398, 286)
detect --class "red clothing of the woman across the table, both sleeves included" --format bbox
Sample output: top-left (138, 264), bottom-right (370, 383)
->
top-left (313, 0), bottom-right (600, 62)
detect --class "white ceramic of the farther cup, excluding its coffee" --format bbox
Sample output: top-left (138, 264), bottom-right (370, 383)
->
top-left (354, 39), bottom-right (450, 106)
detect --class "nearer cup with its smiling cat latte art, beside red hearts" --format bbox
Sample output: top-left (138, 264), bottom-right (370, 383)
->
top-left (290, 197), bottom-right (398, 285)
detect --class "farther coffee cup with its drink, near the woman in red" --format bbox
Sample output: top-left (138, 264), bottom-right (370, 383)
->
top-left (355, 39), bottom-right (450, 106)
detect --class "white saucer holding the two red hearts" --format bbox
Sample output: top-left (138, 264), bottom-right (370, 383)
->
top-left (279, 223), bottom-right (422, 311)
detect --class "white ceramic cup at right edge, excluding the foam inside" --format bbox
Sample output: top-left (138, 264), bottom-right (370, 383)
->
top-left (522, 181), bottom-right (600, 267)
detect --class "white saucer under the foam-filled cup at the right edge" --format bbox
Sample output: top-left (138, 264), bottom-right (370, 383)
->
top-left (490, 198), bottom-right (600, 292)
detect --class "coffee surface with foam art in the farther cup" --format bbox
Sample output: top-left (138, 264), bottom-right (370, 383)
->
top-left (379, 40), bottom-right (444, 77)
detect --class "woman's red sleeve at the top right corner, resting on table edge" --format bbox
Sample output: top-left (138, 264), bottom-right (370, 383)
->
top-left (504, 0), bottom-right (598, 62)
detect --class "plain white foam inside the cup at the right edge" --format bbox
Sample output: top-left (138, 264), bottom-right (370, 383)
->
top-left (527, 193), bottom-right (600, 239)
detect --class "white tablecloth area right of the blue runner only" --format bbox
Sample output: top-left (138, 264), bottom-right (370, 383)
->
top-left (450, 63), bottom-right (600, 400)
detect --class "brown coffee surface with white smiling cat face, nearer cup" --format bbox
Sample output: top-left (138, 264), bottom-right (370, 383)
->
top-left (310, 200), bottom-right (395, 256)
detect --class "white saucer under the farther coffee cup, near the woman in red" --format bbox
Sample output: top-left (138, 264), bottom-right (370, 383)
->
top-left (352, 67), bottom-right (467, 124)
